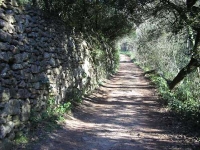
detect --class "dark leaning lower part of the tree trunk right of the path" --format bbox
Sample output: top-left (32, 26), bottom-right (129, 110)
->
top-left (169, 58), bottom-right (199, 90)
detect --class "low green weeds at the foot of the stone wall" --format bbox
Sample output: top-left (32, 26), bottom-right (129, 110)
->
top-left (14, 97), bottom-right (72, 145)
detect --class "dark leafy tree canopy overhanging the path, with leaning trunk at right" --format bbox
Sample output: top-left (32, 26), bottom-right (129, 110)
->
top-left (19, 0), bottom-right (200, 90)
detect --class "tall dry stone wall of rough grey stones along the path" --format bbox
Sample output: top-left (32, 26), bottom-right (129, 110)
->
top-left (0, 0), bottom-right (115, 141)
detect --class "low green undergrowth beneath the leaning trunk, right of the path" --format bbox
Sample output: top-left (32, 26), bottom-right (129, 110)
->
top-left (148, 74), bottom-right (200, 129)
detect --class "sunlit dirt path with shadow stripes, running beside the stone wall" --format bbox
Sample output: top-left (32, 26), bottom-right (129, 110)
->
top-left (20, 55), bottom-right (198, 150)
